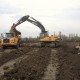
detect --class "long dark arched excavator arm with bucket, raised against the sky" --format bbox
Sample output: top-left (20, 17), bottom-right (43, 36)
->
top-left (10, 15), bottom-right (47, 35)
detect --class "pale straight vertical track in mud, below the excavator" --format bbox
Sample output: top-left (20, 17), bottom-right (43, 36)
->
top-left (42, 49), bottom-right (58, 80)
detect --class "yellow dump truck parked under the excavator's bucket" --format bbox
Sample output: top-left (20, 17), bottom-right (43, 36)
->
top-left (0, 33), bottom-right (19, 49)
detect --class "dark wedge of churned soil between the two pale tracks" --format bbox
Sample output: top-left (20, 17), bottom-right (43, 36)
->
top-left (3, 48), bottom-right (51, 80)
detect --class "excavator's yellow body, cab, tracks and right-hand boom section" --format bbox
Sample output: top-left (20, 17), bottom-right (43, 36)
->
top-left (21, 16), bottom-right (61, 47)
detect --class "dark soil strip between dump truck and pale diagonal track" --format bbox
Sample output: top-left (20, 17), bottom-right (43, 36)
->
top-left (0, 47), bottom-right (32, 66)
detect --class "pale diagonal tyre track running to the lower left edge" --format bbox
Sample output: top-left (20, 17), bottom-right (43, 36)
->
top-left (0, 49), bottom-right (38, 76)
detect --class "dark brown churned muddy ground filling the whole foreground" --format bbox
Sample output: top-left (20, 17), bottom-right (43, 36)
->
top-left (0, 42), bottom-right (80, 80)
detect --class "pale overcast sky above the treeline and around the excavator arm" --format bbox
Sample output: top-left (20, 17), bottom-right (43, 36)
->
top-left (0, 0), bottom-right (80, 37)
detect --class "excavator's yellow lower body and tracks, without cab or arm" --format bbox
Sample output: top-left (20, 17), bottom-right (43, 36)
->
top-left (40, 35), bottom-right (60, 47)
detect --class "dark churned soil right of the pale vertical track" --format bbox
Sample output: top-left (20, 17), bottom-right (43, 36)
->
top-left (56, 42), bottom-right (80, 80)
